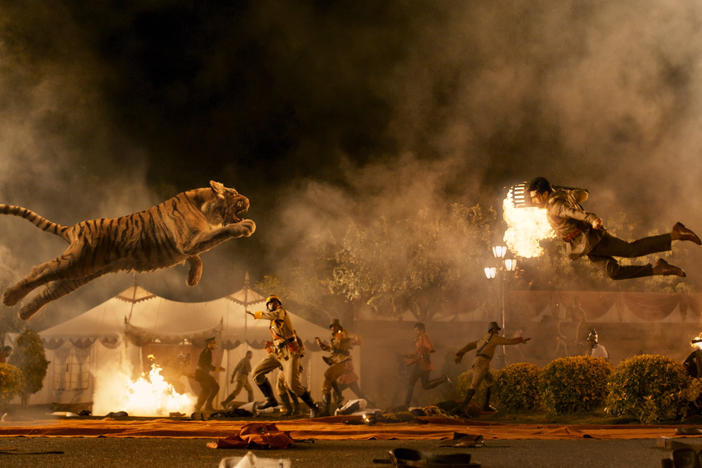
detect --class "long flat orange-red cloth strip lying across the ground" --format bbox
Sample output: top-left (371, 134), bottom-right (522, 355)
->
top-left (0, 416), bottom-right (702, 440)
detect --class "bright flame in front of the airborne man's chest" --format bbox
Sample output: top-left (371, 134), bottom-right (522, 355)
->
top-left (502, 196), bottom-right (556, 258)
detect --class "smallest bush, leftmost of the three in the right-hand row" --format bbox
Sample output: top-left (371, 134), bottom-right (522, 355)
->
top-left (494, 362), bottom-right (540, 412)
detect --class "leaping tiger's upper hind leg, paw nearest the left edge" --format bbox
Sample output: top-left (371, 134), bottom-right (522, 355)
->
top-left (2, 247), bottom-right (86, 306)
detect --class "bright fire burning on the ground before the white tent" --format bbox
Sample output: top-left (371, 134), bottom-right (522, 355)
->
top-left (93, 362), bottom-right (196, 416)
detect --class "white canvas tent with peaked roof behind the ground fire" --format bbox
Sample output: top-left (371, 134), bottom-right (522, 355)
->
top-left (31, 278), bottom-right (338, 404)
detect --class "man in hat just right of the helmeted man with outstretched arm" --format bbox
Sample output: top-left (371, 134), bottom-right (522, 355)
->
top-left (314, 319), bottom-right (361, 416)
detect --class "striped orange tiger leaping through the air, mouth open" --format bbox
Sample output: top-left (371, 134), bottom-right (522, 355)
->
top-left (0, 181), bottom-right (256, 320)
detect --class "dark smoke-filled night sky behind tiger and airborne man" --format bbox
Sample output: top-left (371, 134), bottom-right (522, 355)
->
top-left (0, 0), bottom-right (702, 344)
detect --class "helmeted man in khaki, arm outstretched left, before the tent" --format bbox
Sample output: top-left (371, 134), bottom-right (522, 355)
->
top-left (246, 296), bottom-right (319, 418)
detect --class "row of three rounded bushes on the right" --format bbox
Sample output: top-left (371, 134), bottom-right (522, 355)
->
top-left (458, 354), bottom-right (702, 423)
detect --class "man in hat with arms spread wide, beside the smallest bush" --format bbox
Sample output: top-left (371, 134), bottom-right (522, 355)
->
top-left (456, 322), bottom-right (531, 411)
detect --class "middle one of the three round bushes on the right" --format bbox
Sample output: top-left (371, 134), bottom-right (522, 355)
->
top-left (539, 356), bottom-right (612, 414)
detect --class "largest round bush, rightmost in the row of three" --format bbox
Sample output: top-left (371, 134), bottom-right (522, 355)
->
top-left (606, 354), bottom-right (691, 423)
